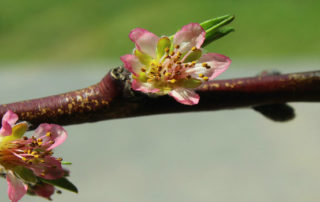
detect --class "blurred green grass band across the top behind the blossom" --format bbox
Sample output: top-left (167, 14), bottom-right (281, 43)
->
top-left (0, 0), bottom-right (320, 63)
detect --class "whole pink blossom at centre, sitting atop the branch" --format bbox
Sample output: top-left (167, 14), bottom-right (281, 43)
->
top-left (121, 23), bottom-right (231, 105)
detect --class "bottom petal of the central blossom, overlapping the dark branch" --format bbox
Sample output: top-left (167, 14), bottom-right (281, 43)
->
top-left (169, 88), bottom-right (200, 105)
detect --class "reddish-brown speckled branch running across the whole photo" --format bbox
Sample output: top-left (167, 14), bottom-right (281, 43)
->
top-left (0, 68), bottom-right (320, 128)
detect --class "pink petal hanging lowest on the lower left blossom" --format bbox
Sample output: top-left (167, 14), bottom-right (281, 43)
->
top-left (7, 171), bottom-right (28, 202)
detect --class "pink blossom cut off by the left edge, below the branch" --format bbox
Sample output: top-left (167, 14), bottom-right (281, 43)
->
top-left (0, 111), bottom-right (67, 202)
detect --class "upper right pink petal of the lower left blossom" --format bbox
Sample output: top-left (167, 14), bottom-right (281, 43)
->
top-left (33, 123), bottom-right (68, 150)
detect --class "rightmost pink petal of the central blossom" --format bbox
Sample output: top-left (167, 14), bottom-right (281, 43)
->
top-left (198, 53), bottom-right (231, 79)
